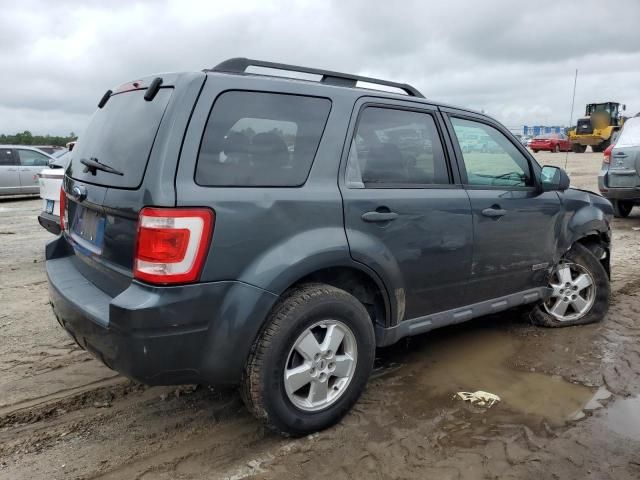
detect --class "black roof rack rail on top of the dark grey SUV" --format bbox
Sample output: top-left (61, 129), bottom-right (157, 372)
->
top-left (204, 57), bottom-right (424, 98)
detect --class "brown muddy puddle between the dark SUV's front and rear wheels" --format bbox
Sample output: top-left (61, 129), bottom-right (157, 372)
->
top-left (378, 321), bottom-right (608, 426)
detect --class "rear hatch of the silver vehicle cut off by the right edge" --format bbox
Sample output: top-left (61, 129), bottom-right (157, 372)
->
top-left (608, 117), bottom-right (640, 188)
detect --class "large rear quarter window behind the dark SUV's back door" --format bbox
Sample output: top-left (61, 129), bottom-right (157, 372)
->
top-left (196, 91), bottom-right (331, 187)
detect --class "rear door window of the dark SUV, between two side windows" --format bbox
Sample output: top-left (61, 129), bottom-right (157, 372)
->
top-left (346, 107), bottom-right (449, 188)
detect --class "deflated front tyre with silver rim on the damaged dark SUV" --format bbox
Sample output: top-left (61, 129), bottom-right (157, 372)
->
top-left (531, 243), bottom-right (611, 327)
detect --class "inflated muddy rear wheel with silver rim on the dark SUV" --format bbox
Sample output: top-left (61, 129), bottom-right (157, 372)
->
top-left (241, 283), bottom-right (376, 437)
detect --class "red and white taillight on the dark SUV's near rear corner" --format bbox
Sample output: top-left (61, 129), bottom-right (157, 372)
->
top-left (133, 207), bottom-right (215, 284)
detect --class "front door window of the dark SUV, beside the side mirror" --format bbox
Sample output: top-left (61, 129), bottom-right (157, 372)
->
top-left (451, 117), bottom-right (533, 187)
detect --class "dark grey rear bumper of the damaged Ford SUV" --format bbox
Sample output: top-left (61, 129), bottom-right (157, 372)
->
top-left (46, 238), bottom-right (277, 385)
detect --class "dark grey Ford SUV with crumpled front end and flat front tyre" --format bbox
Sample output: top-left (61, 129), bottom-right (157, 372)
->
top-left (46, 59), bottom-right (612, 435)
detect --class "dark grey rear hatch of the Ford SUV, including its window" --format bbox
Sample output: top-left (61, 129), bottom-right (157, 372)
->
top-left (63, 73), bottom-right (206, 296)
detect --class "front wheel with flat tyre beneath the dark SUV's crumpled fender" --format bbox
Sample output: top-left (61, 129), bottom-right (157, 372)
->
top-left (531, 244), bottom-right (611, 327)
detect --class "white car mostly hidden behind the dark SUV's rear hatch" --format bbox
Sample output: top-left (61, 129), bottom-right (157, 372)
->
top-left (38, 152), bottom-right (71, 235)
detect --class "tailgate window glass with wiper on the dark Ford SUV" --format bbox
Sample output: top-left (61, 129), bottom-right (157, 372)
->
top-left (68, 88), bottom-right (173, 188)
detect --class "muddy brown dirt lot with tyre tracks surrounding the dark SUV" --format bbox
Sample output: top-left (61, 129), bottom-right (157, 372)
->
top-left (0, 154), bottom-right (640, 480)
